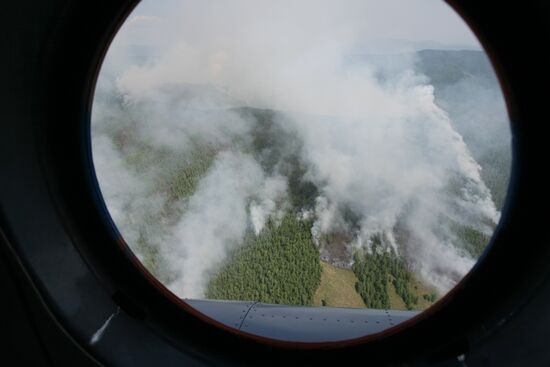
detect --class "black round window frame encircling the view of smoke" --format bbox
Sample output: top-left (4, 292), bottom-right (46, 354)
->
top-left (3, 1), bottom-right (550, 363)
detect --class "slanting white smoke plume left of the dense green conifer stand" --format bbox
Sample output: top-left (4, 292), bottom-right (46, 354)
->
top-left (162, 152), bottom-right (285, 298)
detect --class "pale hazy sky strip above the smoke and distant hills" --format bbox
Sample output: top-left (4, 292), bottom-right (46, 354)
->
top-left (129, 0), bottom-right (480, 51)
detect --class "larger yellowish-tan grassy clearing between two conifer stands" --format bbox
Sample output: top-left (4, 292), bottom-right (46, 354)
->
top-left (313, 261), bottom-right (366, 308)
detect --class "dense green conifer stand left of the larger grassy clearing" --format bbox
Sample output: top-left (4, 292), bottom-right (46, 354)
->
top-left (206, 214), bottom-right (321, 305)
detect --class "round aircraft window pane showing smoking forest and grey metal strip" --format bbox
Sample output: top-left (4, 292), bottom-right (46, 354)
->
top-left (91, 0), bottom-right (511, 340)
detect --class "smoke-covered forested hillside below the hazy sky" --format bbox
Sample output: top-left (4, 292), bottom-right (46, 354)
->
top-left (93, 50), bottom-right (511, 309)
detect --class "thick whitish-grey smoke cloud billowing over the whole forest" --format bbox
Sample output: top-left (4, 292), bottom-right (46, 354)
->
top-left (93, 0), bottom-right (508, 298)
